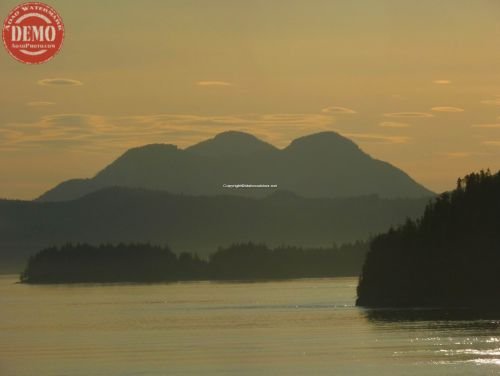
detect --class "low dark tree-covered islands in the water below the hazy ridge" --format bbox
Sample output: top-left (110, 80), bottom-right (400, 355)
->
top-left (21, 242), bottom-right (367, 283)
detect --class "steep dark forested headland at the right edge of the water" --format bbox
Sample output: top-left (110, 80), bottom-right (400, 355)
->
top-left (357, 171), bottom-right (500, 307)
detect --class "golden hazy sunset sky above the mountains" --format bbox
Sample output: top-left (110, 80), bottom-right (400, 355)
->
top-left (0, 0), bottom-right (500, 199)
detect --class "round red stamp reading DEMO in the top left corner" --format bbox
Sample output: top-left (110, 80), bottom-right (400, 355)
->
top-left (2, 2), bottom-right (64, 64)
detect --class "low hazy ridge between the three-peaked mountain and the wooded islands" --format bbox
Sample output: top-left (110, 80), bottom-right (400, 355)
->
top-left (0, 187), bottom-right (428, 270)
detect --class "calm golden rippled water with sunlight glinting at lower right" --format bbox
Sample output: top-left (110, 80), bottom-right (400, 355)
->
top-left (0, 276), bottom-right (500, 376)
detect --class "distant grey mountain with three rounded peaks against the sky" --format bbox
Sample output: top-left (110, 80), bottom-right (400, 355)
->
top-left (38, 131), bottom-right (433, 201)
